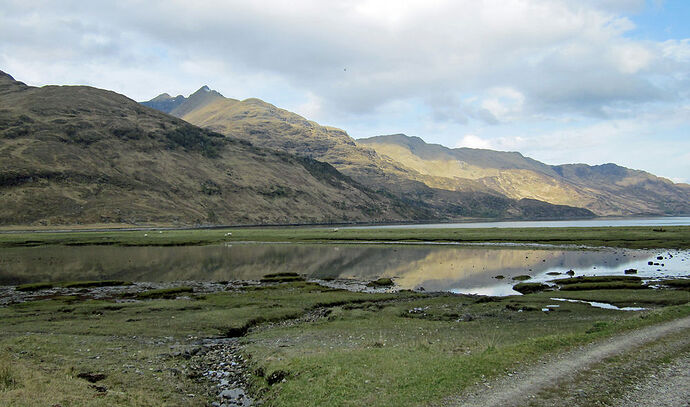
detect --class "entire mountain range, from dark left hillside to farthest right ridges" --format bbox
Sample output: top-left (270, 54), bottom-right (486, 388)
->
top-left (0, 72), bottom-right (690, 230)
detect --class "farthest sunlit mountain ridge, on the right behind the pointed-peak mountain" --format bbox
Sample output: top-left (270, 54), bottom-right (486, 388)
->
top-left (357, 134), bottom-right (690, 216)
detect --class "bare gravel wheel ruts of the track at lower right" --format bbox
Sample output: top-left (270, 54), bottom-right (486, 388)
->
top-left (444, 317), bottom-right (690, 407)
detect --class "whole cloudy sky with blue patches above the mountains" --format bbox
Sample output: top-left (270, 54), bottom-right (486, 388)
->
top-left (0, 0), bottom-right (690, 182)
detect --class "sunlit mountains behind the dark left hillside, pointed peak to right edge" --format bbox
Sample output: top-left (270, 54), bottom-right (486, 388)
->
top-left (143, 87), bottom-right (690, 219)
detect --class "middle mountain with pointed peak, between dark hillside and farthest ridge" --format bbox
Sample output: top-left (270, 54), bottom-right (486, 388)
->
top-left (143, 88), bottom-right (592, 220)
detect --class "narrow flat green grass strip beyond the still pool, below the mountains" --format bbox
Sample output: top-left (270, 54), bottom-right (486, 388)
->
top-left (0, 226), bottom-right (690, 249)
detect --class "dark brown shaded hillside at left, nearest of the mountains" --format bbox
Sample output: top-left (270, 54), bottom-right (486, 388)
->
top-left (0, 72), bottom-right (424, 225)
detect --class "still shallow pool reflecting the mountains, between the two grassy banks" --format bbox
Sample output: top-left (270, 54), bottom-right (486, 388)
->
top-left (0, 244), bottom-right (690, 295)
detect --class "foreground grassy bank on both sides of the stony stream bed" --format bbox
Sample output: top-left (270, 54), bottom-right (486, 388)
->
top-left (0, 282), bottom-right (690, 406)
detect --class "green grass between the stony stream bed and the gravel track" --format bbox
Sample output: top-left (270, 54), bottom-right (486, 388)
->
top-left (246, 296), bottom-right (690, 406)
